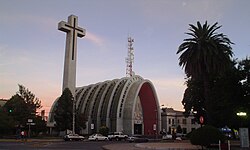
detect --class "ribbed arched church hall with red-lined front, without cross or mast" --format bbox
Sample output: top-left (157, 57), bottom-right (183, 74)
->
top-left (48, 75), bottom-right (161, 135)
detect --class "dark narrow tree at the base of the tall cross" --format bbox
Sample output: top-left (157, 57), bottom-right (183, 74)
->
top-left (54, 88), bottom-right (73, 131)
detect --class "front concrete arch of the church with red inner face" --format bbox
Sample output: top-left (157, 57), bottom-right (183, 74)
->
top-left (123, 80), bottom-right (160, 135)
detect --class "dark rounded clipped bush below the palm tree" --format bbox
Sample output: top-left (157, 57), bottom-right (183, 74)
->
top-left (190, 125), bottom-right (225, 146)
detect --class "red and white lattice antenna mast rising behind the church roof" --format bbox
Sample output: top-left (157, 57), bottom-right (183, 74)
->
top-left (126, 37), bottom-right (135, 77)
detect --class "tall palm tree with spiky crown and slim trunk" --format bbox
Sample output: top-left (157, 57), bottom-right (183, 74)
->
top-left (177, 21), bottom-right (233, 124)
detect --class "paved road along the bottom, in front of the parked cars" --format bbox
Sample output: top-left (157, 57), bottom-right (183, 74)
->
top-left (0, 139), bottom-right (246, 150)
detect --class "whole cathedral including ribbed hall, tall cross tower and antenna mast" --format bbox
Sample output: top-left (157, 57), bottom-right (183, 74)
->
top-left (47, 15), bottom-right (161, 135)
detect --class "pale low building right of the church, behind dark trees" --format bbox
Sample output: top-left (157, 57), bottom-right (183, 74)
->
top-left (161, 108), bottom-right (200, 134)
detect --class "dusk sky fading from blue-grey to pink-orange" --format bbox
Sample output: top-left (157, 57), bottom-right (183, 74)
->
top-left (0, 0), bottom-right (250, 115)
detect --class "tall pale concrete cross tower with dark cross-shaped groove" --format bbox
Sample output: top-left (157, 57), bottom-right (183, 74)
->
top-left (58, 15), bottom-right (85, 96)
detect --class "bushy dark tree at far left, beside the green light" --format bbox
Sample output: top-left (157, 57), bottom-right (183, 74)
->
top-left (1, 85), bottom-right (46, 134)
